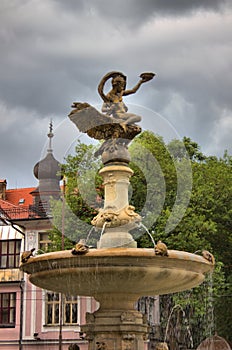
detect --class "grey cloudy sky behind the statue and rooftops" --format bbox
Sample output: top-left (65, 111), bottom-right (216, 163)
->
top-left (0, 0), bottom-right (232, 188)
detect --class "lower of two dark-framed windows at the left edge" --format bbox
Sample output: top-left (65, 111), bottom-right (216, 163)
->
top-left (0, 293), bottom-right (16, 327)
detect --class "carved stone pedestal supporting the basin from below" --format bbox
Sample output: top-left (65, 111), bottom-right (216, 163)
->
top-left (82, 294), bottom-right (148, 350)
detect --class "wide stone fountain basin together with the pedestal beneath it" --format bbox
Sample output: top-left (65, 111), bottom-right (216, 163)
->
top-left (21, 248), bottom-right (213, 350)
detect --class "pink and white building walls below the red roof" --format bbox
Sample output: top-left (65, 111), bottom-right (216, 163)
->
top-left (0, 221), bottom-right (98, 350)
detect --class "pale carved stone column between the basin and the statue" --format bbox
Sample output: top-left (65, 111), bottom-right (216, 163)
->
top-left (92, 164), bottom-right (141, 248)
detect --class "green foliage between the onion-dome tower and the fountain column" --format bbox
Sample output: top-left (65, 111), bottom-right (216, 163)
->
top-left (49, 141), bottom-right (102, 251)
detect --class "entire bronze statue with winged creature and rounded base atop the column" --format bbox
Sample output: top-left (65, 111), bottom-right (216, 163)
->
top-left (69, 71), bottom-right (155, 164)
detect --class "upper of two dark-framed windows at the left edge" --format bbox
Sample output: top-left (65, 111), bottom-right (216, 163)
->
top-left (0, 239), bottom-right (21, 269)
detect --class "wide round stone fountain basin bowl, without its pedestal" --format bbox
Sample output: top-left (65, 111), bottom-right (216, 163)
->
top-left (21, 248), bottom-right (213, 304)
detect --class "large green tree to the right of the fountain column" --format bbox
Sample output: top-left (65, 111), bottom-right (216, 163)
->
top-left (131, 132), bottom-right (232, 345)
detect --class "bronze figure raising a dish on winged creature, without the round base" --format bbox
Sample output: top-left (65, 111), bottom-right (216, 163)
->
top-left (69, 72), bottom-right (155, 140)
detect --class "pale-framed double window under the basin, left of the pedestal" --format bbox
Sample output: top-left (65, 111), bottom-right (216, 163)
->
top-left (46, 292), bottom-right (78, 325)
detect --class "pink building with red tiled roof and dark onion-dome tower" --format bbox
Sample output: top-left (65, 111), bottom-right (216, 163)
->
top-left (0, 127), bottom-right (98, 350)
